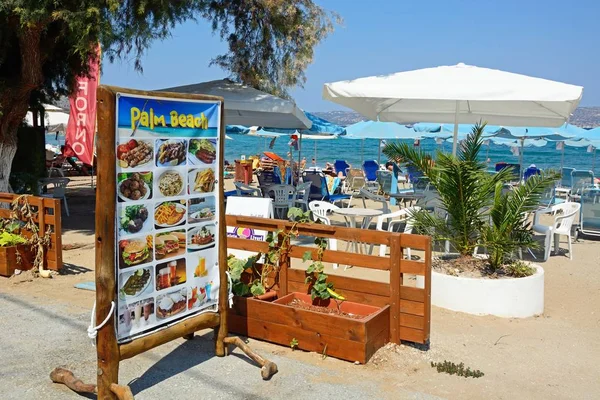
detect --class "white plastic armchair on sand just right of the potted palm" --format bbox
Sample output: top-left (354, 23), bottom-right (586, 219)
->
top-left (532, 202), bottom-right (581, 261)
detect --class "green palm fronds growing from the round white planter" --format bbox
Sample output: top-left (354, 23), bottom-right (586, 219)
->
top-left (383, 123), bottom-right (558, 274)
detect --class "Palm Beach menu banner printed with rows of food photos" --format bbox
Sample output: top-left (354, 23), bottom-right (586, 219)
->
top-left (115, 93), bottom-right (221, 342)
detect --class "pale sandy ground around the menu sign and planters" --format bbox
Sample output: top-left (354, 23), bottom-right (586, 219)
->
top-left (0, 178), bottom-right (600, 399)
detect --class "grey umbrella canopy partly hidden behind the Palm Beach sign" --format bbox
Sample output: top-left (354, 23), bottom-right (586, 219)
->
top-left (160, 79), bottom-right (312, 129)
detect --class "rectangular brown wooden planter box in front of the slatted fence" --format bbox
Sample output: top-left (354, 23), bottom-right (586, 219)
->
top-left (227, 292), bottom-right (390, 364)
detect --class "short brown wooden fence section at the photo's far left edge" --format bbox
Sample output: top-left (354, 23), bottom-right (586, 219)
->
top-left (0, 193), bottom-right (63, 271)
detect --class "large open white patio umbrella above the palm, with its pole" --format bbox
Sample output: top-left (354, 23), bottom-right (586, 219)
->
top-left (323, 63), bottom-right (583, 154)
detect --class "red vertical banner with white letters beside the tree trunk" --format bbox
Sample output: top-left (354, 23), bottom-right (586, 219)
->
top-left (65, 47), bottom-right (100, 165)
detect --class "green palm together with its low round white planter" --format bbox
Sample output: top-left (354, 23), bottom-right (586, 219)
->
top-left (383, 124), bottom-right (558, 317)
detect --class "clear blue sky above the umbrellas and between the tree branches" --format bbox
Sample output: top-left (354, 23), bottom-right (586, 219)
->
top-left (101, 0), bottom-right (600, 111)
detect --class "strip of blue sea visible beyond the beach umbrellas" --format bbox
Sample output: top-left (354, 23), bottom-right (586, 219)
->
top-left (46, 134), bottom-right (600, 176)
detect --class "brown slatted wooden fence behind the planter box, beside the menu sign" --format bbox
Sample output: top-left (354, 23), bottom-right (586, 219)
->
top-left (226, 215), bottom-right (431, 344)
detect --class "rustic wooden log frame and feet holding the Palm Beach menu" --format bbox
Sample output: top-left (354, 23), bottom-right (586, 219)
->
top-left (50, 86), bottom-right (277, 399)
